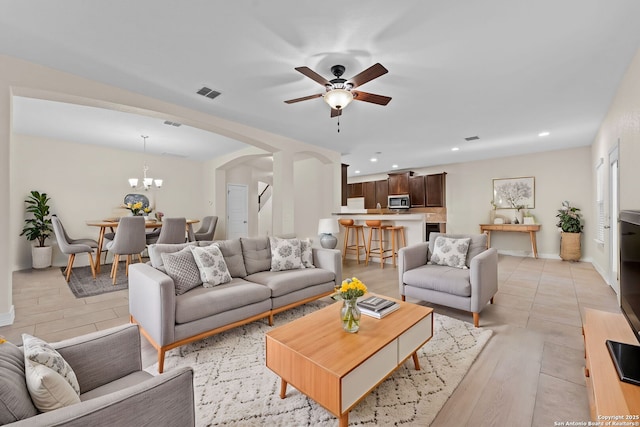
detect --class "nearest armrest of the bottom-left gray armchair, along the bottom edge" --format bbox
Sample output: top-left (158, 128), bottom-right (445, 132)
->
top-left (12, 368), bottom-right (195, 427)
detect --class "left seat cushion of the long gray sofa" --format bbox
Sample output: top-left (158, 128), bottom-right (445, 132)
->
top-left (176, 278), bottom-right (271, 324)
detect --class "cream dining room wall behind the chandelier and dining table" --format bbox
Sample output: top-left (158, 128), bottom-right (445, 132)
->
top-left (10, 135), bottom-right (206, 270)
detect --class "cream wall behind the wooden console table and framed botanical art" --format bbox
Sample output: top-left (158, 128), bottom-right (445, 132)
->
top-left (353, 146), bottom-right (595, 260)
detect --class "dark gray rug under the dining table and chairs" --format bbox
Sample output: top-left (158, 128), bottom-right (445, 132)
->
top-left (60, 262), bottom-right (129, 298)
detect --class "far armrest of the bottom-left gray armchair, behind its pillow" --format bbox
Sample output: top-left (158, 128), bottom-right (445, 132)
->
top-left (52, 324), bottom-right (142, 393)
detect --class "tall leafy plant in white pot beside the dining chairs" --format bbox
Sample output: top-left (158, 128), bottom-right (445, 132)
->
top-left (20, 191), bottom-right (53, 268)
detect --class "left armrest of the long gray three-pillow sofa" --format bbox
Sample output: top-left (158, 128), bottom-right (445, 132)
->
top-left (129, 263), bottom-right (176, 346)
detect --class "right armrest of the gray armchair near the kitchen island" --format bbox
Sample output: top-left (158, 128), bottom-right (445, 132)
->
top-left (469, 248), bottom-right (498, 313)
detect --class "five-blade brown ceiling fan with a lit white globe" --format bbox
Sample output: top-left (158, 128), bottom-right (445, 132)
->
top-left (284, 63), bottom-right (391, 117)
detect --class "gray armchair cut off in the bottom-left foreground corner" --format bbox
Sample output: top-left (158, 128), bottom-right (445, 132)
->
top-left (0, 324), bottom-right (195, 427)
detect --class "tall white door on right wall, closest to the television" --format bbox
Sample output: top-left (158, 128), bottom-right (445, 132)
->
top-left (609, 145), bottom-right (620, 295)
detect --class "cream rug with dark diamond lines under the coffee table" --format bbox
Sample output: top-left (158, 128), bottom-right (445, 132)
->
top-left (147, 301), bottom-right (492, 427)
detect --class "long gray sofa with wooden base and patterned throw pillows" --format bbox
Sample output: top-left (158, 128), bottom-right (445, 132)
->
top-left (129, 237), bottom-right (342, 372)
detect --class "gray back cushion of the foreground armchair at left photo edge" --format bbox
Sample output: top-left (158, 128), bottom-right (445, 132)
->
top-left (0, 337), bottom-right (38, 425)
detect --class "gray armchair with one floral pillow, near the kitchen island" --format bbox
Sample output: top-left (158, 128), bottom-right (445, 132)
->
top-left (398, 233), bottom-right (498, 327)
